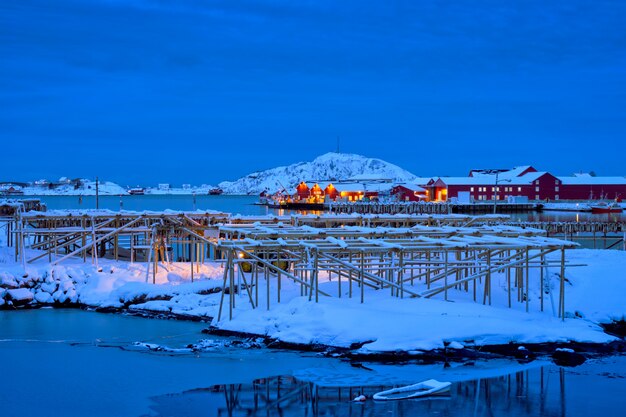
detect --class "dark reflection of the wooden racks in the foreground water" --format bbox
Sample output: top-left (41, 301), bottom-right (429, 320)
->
top-left (143, 366), bottom-right (584, 417)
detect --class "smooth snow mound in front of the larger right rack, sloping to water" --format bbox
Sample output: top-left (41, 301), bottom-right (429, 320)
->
top-left (214, 290), bottom-right (614, 353)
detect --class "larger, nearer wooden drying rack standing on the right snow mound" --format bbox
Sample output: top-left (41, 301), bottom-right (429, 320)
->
top-left (216, 224), bottom-right (577, 320)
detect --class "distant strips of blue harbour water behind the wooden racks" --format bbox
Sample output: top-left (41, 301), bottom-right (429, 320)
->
top-left (24, 195), bottom-right (626, 222)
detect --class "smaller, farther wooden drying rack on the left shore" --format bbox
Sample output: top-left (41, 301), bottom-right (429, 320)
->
top-left (9, 210), bottom-right (228, 282)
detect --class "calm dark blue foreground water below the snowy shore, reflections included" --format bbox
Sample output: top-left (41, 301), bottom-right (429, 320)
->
top-left (0, 309), bottom-right (626, 417)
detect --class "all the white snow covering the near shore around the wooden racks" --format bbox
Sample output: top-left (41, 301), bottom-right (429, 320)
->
top-left (0, 226), bottom-right (626, 353)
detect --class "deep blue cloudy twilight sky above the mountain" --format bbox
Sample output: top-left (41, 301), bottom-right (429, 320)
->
top-left (0, 0), bottom-right (626, 184)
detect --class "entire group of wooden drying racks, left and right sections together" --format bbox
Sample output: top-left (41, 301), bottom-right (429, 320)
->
top-left (12, 211), bottom-right (577, 320)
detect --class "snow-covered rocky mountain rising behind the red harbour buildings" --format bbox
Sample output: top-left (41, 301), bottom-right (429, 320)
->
top-left (219, 152), bottom-right (415, 194)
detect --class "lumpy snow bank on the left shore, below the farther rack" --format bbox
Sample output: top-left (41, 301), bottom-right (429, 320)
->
top-left (0, 244), bottom-right (223, 317)
